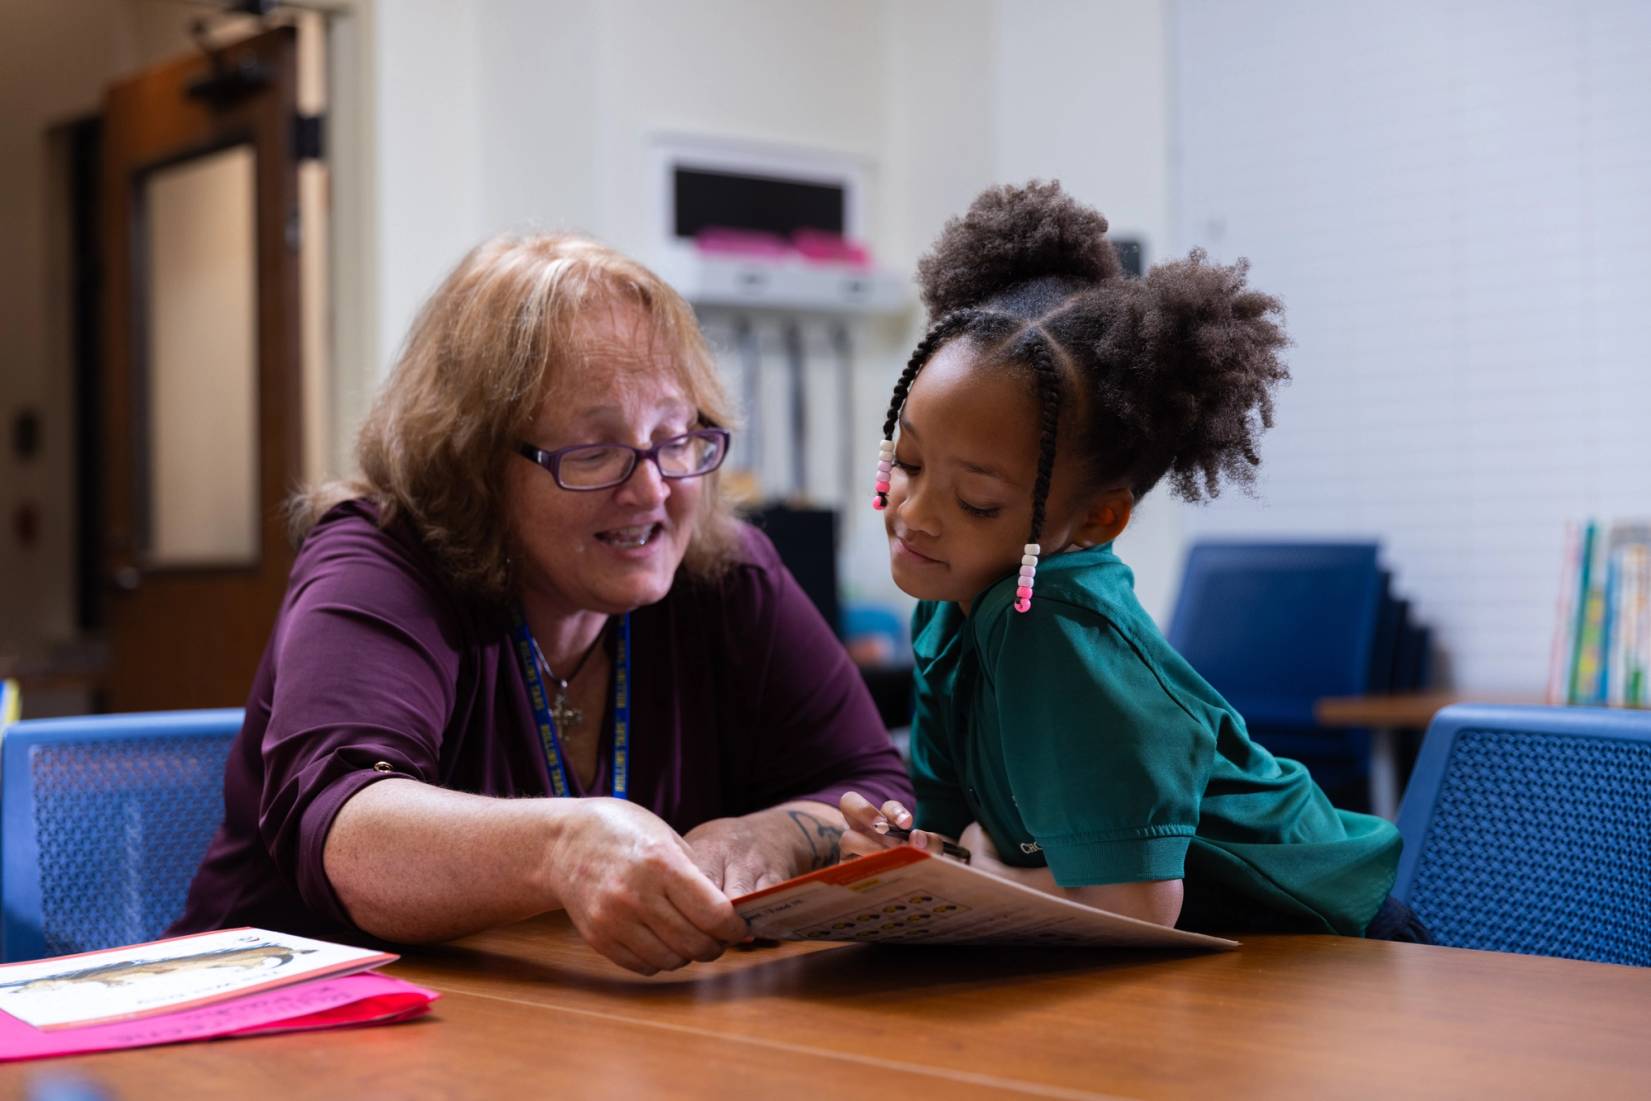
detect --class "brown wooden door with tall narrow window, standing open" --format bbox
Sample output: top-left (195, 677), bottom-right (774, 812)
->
top-left (102, 28), bottom-right (302, 711)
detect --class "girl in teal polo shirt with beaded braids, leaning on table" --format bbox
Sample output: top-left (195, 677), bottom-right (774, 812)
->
top-left (842, 183), bottom-right (1425, 939)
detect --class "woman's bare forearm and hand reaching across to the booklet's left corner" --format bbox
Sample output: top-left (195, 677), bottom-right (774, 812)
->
top-left (322, 779), bottom-right (746, 974)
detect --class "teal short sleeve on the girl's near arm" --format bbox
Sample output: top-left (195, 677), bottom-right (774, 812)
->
top-left (981, 594), bottom-right (1215, 886)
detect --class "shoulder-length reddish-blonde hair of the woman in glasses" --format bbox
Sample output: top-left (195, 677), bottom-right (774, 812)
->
top-left (287, 234), bottom-right (738, 602)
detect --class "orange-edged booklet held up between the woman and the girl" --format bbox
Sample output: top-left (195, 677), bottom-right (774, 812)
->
top-left (733, 845), bottom-right (1238, 949)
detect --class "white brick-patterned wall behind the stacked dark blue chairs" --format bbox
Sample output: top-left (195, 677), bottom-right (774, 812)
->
top-left (1174, 0), bottom-right (1651, 693)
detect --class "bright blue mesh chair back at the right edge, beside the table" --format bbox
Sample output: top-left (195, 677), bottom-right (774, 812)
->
top-left (1393, 705), bottom-right (1651, 966)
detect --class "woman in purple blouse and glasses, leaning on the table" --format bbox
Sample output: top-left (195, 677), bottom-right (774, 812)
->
top-left (173, 236), bottom-right (910, 974)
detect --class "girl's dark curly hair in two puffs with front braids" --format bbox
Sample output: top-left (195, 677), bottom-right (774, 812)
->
top-left (883, 180), bottom-right (1289, 543)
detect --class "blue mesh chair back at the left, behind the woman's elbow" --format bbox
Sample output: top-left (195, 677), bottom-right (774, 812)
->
top-left (0, 708), bottom-right (241, 962)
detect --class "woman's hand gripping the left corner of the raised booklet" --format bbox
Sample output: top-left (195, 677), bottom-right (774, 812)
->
top-left (548, 799), bottom-right (748, 976)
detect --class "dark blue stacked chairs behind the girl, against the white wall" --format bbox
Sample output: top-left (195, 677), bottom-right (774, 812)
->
top-left (1169, 541), bottom-right (1397, 799)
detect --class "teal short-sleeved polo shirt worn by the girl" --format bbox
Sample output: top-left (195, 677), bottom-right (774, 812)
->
top-left (911, 545), bottom-right (1400, 936)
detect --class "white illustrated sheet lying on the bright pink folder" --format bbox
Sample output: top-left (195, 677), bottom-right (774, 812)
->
top-left (0, 928), bottom-right (396, 1030)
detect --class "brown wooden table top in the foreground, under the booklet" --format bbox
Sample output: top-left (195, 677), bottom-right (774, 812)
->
top-left (16, 916), bottom-right (1651, 1101)
